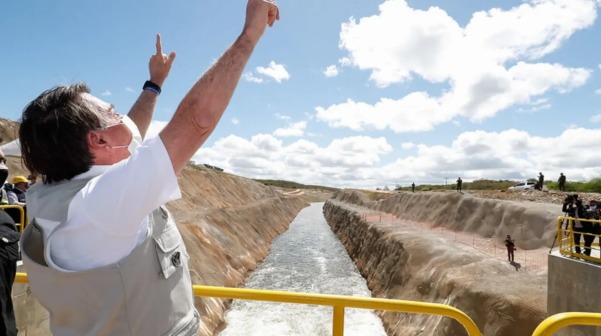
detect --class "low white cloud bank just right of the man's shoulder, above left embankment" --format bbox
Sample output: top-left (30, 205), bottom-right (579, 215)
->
top-left (193, 134), bottom-right (392, 185)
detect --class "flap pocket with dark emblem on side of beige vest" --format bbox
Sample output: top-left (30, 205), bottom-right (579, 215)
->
top-left (153, 227), bottom-right (189, 279)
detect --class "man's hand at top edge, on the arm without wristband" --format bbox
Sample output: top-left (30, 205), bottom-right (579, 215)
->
top-left (243, 0), bottom-right (280, 41)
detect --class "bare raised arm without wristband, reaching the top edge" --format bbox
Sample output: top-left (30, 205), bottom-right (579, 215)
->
top-left (160, 0), bottom-right (279, 173)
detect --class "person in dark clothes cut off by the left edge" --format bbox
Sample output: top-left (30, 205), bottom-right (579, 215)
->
top-left (0, 211), bottom-right (20, 336)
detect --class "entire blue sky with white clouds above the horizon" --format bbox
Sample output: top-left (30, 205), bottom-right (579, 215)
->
top-left (0, 0), bottom-right (601, 188)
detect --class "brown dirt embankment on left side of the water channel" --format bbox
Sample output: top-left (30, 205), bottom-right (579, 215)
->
top-left (13, 167), bottom-right (308, 336)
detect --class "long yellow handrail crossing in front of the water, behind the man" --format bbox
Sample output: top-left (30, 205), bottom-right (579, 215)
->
top-left (15, 272), bottom-right (482, 336)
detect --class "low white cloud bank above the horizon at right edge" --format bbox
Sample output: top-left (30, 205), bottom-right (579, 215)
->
top-left (382, 128), bottom-right (601, 182)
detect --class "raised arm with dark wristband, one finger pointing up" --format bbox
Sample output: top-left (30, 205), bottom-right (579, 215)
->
top-left (127, 34), bottom-right (175, 138)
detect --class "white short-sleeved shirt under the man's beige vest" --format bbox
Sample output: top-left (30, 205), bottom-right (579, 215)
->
top-left (28, 136), bottom-right (181, 271)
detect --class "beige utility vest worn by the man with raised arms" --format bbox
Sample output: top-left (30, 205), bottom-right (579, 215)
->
top-left (21, 180), bottom-right (199, 336)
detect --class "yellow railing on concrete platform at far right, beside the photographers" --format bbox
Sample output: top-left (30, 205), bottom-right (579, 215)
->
top-left (557, 216), bottom-right (601, 263)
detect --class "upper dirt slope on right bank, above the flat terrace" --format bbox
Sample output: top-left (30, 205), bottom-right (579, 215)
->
top-left (336, 190), bottom-right (563, 250)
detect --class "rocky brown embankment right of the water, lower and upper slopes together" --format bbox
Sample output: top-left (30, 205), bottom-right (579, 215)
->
top-left (324, 191), bottom-right (553, 336)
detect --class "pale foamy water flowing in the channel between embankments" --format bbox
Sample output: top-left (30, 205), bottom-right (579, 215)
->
top-left (220, 203), bottom-right (386, 336)
